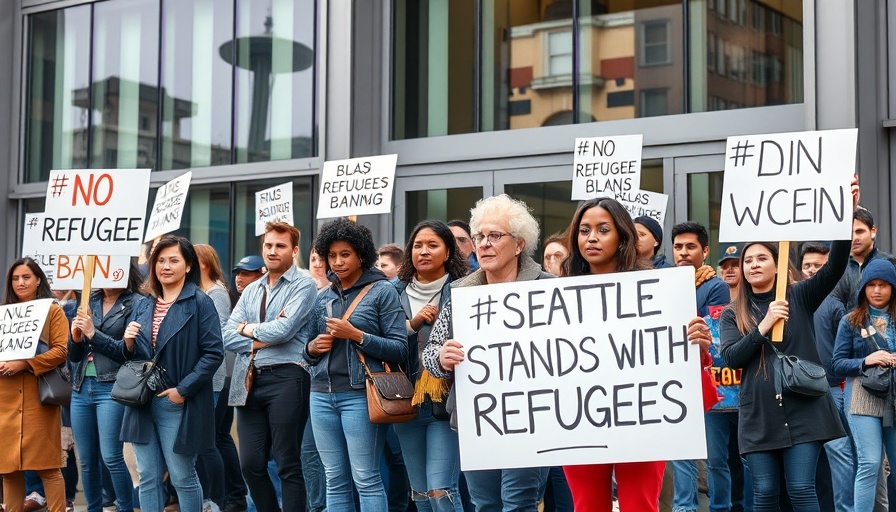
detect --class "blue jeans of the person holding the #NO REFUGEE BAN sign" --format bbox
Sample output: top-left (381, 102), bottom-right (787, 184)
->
top-left (71, 377), bottom-right (134, 512)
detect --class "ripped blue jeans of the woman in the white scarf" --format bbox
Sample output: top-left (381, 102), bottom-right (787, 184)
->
top-left (395, 402), bottom-right (463, 512)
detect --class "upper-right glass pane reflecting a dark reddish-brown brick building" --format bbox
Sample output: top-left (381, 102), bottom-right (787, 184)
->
top-left (688, 0), bottom-right (805, 112)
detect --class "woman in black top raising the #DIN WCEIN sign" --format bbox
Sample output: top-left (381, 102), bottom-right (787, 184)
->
top-left (720, 177), bottom-right (859, 512)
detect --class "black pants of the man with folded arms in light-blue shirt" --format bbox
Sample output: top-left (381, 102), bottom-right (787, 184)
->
top-left (236, 364), bottom-right (310, 512)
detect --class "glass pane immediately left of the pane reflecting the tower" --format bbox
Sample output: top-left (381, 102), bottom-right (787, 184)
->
top-left (161, 0), bottom-right (233, 170)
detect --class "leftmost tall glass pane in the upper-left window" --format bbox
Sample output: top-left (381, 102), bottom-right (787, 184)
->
top-left (25, 5), bottom-right (90, 182)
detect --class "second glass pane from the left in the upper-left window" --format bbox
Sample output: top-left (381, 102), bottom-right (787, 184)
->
top-left (90, 0), bottom-right (159, 169)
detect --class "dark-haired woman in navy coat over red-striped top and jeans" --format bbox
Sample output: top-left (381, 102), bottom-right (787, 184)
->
top-left (121, 235), bottom-right (224, 512)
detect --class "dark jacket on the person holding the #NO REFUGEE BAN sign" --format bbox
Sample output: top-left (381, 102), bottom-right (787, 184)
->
top-left (68, 290), bottom-right (142, 392)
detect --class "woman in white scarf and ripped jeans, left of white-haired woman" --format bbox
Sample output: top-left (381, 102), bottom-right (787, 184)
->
top-left (395, 220), bottom-right (469, 512)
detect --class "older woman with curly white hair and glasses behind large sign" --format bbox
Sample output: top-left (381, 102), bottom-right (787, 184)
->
top-left (423, 194), bottom-right (553, 512)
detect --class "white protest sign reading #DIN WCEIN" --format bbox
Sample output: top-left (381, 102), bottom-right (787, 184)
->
top-left (719, 129), bottom-right (858, 242)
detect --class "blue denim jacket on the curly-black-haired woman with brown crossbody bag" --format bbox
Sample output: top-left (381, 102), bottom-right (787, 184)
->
top-left (303, 270), bottom-right (408, 393)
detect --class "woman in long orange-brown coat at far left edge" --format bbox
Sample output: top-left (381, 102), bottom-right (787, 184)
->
top-left (0, 258), bottom-right (68, 512)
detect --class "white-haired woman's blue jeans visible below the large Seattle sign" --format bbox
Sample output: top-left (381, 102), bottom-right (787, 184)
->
top-left (464, 468), bottom-right (550, 512)
